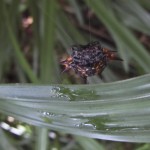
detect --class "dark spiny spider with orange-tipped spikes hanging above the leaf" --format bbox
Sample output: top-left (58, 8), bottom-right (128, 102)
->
top-left (60, 41), bottom-right (122, 79)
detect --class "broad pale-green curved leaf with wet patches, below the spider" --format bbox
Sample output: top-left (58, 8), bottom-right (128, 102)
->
top-left (0, 74), bottom-right (150, 142)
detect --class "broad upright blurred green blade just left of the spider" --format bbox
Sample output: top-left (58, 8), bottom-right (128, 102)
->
top-left (40, 0), bottom-right (57, 83)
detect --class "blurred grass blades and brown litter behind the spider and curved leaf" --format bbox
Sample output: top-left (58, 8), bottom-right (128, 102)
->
top-left (0, 0), bottom-right (150, 150)
